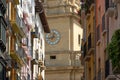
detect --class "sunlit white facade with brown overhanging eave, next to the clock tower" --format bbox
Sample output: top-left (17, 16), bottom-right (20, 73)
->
top-left (31, 0), bottom-right (50, 80)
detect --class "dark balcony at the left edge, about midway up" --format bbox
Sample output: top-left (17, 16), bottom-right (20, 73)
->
top-left (0, 15), bottom-right (7, 52)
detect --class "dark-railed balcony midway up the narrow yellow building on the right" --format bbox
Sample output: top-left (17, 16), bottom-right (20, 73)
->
top-left (87, 33), bottom-right (94, 54)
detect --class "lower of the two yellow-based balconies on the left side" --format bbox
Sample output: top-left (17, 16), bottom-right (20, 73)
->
top-left (10, 36), bottom-right (25, 66)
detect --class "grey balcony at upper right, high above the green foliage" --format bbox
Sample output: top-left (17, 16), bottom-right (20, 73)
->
top-left (106, 0), bottom-right (115, 17)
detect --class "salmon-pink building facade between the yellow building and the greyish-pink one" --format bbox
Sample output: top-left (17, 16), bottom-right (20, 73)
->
top-left (95, 0), bottom-right (107, 80)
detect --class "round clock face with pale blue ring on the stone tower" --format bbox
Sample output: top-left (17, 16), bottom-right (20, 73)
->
top-left (46, 29), bottom-right (60, 45)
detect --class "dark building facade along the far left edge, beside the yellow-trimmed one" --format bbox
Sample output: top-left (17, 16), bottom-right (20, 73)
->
top-left (0, 0), bottom-right (7, 80)
